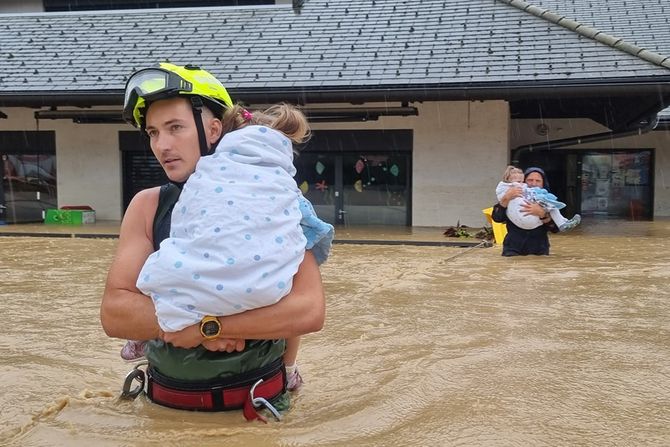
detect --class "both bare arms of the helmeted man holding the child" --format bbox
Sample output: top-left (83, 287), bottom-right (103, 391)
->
top-left (100, 188), bottom-right (325, 347)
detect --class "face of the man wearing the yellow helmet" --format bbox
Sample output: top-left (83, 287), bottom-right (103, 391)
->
top-left (146, 98), bottom-right (206, 182)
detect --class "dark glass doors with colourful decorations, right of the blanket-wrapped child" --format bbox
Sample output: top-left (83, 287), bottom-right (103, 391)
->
top-left (294, 129), bottom-right (413, 226)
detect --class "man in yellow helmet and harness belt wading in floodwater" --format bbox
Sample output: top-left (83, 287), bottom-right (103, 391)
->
top-left (100, 65), bottom-right (325, 419)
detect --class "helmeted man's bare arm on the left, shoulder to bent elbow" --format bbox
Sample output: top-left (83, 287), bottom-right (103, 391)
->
top-left (100, 188), bottom-right (159, 340)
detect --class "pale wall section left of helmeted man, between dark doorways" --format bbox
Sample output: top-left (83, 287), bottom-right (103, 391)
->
top-left (0, 108), bottom-right (128, 220)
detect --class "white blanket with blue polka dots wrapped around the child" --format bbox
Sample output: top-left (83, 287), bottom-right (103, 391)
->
top-left (137, 126), bottom-right (333, 332)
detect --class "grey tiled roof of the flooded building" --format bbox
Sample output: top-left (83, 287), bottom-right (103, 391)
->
top-left (0, 0), bottom-right (670, 104)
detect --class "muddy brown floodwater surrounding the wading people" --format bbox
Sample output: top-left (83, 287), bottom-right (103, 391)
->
top-left (0, 220), bottom-right (670, 447)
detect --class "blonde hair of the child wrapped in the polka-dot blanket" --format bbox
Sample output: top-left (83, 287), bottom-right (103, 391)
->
top-left (221, 103), bottom-right (312, 144)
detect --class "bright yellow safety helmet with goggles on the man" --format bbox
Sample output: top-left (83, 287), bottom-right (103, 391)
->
top-left (123, 62), bottom-right (233, 129)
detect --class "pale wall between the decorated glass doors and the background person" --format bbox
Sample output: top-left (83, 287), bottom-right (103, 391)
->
top-left (412, 101), bottom-right (509, 226)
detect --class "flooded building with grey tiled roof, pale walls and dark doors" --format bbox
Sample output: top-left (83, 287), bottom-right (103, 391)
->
top-left (0, 0), bottom-right (670, 226)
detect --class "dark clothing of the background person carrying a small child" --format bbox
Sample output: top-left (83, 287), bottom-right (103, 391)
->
top-left (491, 203), bottom-right (558, 256)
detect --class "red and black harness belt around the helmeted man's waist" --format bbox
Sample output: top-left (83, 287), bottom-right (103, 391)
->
top-left (147, 359), bottom-right (286, 420)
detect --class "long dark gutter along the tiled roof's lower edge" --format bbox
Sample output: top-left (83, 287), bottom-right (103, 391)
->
top-left (0, 78), bottom-right (670, 107)
